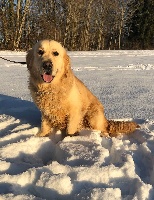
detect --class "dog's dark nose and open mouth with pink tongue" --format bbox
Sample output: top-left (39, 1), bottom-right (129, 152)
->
top-left (41, 61), bottom-right (54, 83)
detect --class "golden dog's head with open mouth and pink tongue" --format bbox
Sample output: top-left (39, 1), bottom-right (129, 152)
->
top-left (26, 40), bottom-right (69, 83)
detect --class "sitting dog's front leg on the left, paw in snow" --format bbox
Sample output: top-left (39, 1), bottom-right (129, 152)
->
top-left (37, 116), bottom-right (54, 137)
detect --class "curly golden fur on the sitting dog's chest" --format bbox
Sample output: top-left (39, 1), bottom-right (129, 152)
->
top-left (34, 86), bottom-right (69, 129)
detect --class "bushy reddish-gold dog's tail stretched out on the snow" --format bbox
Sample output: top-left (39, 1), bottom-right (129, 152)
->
top-left (107, 120), bottom-right (140, 137)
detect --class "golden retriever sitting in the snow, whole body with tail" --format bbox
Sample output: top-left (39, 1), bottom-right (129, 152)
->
top-left (26, 40), bottom-right (139, 136)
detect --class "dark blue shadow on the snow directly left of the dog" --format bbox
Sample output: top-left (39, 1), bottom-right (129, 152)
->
top-left (0, 94), bottom-right (41, 131)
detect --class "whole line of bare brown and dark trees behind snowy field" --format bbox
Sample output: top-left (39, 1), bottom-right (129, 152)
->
top-left (0, 0), bottom-right (154, 50)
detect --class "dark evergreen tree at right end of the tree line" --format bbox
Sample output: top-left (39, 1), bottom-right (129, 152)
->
top-left (127, 0), bottom-right (154, 49)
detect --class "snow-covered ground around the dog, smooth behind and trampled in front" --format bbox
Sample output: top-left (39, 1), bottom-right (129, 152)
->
top-left (0, 51), bottom-right (154, 200)
